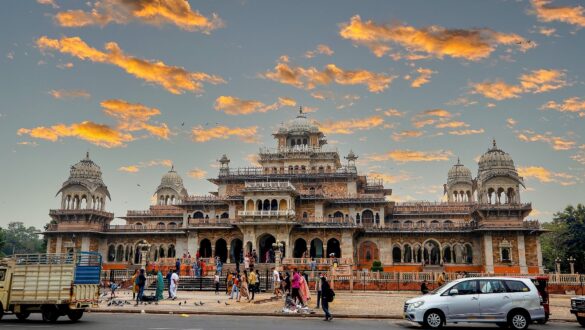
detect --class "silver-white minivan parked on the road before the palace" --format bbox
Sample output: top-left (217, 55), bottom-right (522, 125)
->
top-left (404, 277), bottom-right (545, 329)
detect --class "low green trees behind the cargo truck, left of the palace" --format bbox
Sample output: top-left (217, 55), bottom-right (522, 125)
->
top-left (0, 221), bottom-right (44, 255)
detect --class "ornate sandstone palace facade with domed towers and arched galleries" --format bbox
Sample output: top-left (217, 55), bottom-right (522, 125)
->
top-left (44, 111), bottom-right (543, 274)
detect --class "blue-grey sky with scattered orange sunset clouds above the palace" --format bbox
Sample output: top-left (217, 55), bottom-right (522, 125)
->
top-left (0, 0), bottom-right (585, 227)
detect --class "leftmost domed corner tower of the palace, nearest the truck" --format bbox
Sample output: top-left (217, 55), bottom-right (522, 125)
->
top-left (45, 152), bottom-right (114, 253)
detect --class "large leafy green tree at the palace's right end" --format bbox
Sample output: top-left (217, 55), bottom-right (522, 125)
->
top-left (540, 204), bottom-right (585, 273)
